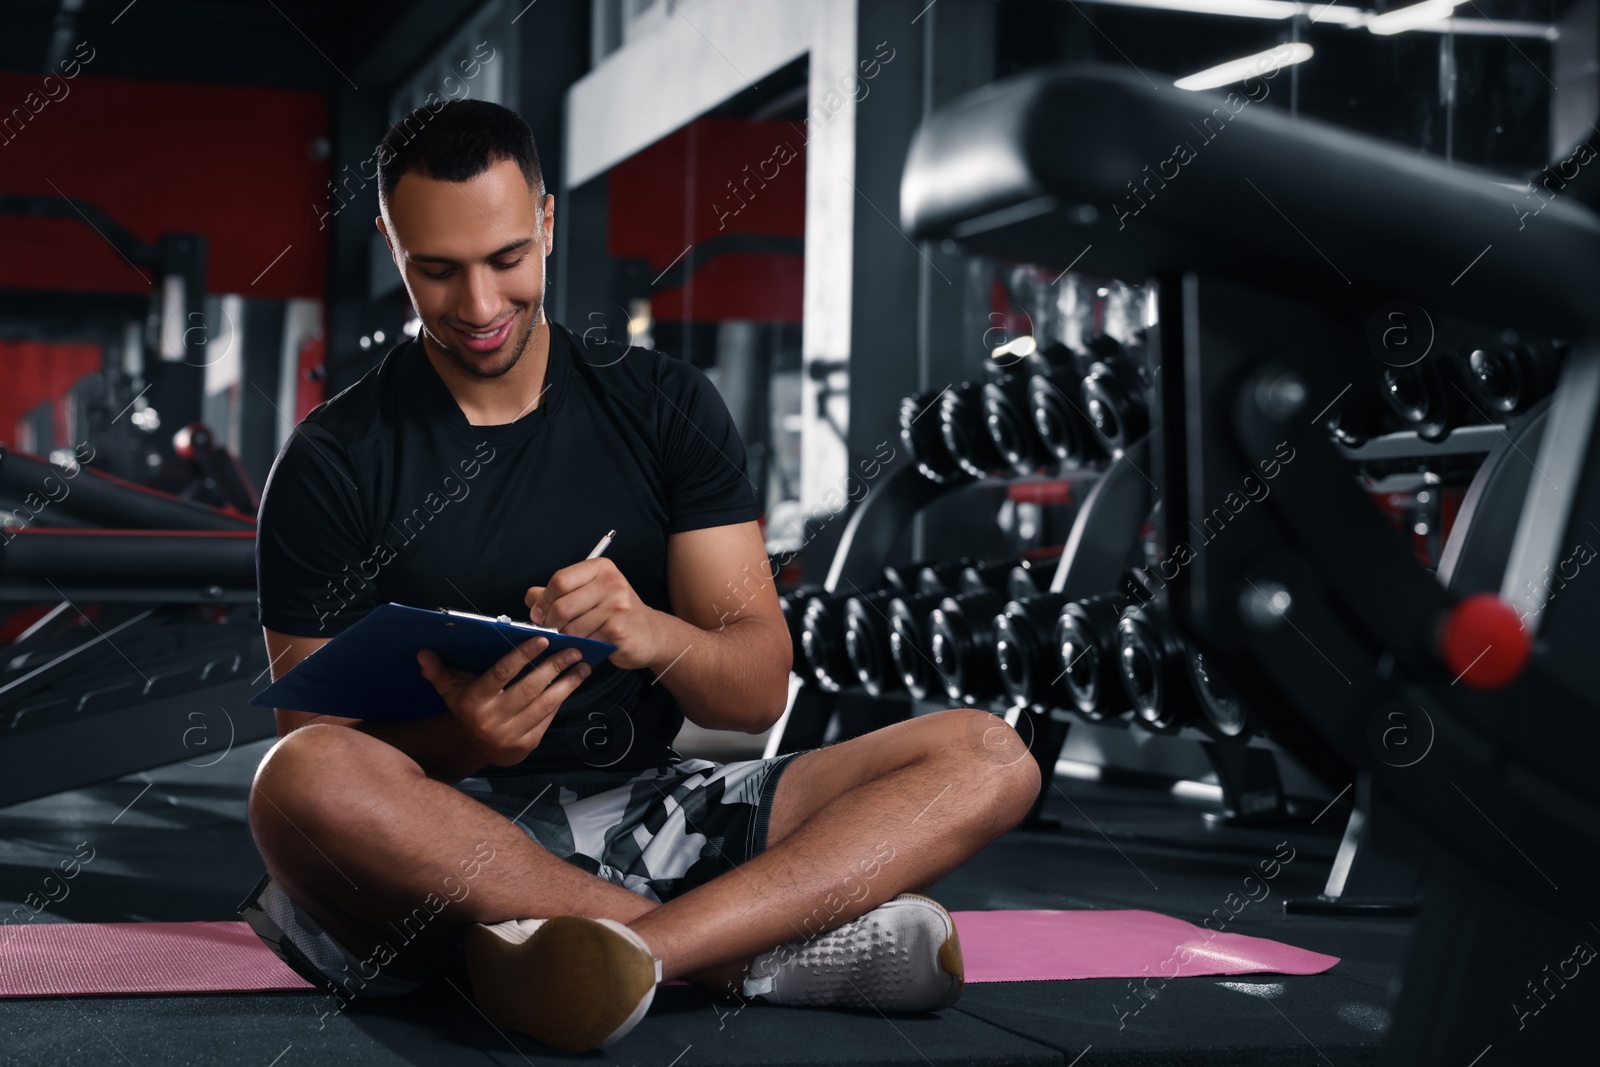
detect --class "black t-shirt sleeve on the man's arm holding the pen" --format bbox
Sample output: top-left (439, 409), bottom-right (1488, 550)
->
top-left (656, 357), bottom-right (762, 534)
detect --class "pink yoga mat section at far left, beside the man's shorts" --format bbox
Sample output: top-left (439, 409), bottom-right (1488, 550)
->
top-left (0, 923), bottom-right (312, 997)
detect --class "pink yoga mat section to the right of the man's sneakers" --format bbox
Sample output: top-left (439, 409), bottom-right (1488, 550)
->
top-left (952, 910), bottom-right (1339, 982)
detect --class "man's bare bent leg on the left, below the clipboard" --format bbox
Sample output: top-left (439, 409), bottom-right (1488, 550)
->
top-left (250, 723), bottom-right (675, 977)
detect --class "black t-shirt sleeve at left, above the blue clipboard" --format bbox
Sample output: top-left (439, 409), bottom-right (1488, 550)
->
top-left (256, 422), bottom-right (379, 637)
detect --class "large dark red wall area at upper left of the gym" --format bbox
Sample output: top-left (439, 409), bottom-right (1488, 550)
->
top-left (0, 67), bottom-right (330, 299)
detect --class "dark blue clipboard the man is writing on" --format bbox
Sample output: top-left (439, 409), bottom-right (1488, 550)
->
top-left (250, 603), bottom-right (616, 720)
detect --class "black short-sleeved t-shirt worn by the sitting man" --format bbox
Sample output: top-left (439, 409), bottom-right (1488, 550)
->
top-left (256, 323), bottom-right (760, 774)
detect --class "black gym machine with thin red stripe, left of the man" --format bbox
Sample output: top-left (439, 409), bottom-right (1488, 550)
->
top-left (0, 441), bottom-right (275, 805)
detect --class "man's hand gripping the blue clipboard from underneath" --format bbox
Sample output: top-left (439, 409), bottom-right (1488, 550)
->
top-left (416, 637), bottom-right (589, 766)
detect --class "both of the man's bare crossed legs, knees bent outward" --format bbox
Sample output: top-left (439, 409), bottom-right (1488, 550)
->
top-left (236, 709), bottom-right (1040, 1037)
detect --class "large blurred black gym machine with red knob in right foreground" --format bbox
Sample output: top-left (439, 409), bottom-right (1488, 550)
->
top-left (901, 69), bottom-right (1600, 1065)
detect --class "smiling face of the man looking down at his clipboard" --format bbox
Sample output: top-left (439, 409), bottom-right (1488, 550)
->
top-left (378, 160), bottom-right (555, 378)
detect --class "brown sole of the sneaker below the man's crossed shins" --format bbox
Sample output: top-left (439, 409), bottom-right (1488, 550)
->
top-left (462, 915), bottom-right (661, 1053)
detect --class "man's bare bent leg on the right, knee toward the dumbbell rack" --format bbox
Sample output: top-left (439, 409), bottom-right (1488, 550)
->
top-left (627, 709), bottom-right (1040, 981)
